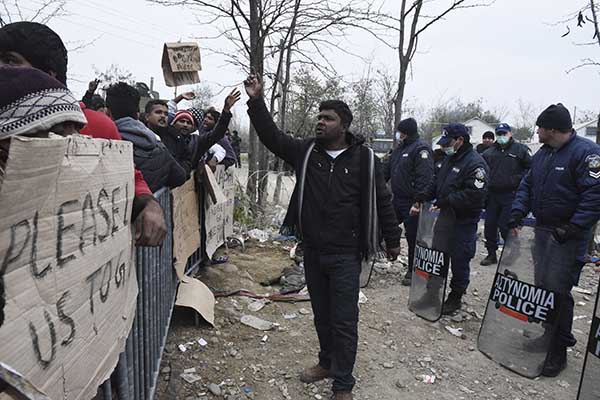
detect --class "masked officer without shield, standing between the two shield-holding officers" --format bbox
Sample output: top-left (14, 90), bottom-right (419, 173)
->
top-left (481, 123), bottom-right (531, 265)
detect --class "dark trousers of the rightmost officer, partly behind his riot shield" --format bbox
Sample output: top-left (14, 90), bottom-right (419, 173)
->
top-left (533, 228), bottom-right (590, 348)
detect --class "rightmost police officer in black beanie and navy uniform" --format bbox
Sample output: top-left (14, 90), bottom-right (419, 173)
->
top-left (509, 103), bottom-right (600, 376)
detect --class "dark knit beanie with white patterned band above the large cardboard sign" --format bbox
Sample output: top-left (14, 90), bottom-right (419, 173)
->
top-left (0, 65), bottom-right (87, 140)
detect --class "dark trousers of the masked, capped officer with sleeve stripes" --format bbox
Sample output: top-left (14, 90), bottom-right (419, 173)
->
top-left (450, 222), bottom-right (477, 292)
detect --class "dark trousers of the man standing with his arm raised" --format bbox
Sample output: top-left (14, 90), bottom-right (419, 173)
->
top-left (304, 248), bottom-right (361, 392)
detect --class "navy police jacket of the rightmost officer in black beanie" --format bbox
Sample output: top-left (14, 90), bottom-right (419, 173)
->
top-left (512, 132), bottom-right (600, 230)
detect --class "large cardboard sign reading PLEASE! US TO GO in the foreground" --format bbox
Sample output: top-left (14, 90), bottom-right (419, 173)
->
top-left (0, 135), bottom-right (137, 400)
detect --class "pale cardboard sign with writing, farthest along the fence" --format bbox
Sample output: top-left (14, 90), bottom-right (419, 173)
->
top-left (204, 165), bottom-right (235, 258)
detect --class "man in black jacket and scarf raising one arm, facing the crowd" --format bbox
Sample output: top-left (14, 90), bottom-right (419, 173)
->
top-left (244, 76), bottom-right (400, 400)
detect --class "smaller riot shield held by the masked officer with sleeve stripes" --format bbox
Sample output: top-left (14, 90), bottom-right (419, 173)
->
top-left (408, 203), bottom-right (455, 322)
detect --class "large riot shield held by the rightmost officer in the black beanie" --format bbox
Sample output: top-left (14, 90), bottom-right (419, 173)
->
top-left (477, 227), bottom-right (577, 378)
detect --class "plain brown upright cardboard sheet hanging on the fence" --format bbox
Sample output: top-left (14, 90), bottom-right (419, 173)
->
top-left (171, 175), bottom-right (200, 279)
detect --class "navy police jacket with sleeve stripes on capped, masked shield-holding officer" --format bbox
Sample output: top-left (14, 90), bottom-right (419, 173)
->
top-left (428, 143), bottom-right (488, 224)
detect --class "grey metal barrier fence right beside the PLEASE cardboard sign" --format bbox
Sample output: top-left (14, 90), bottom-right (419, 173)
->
top-left (97, 188), bottom-right (202, 400)
